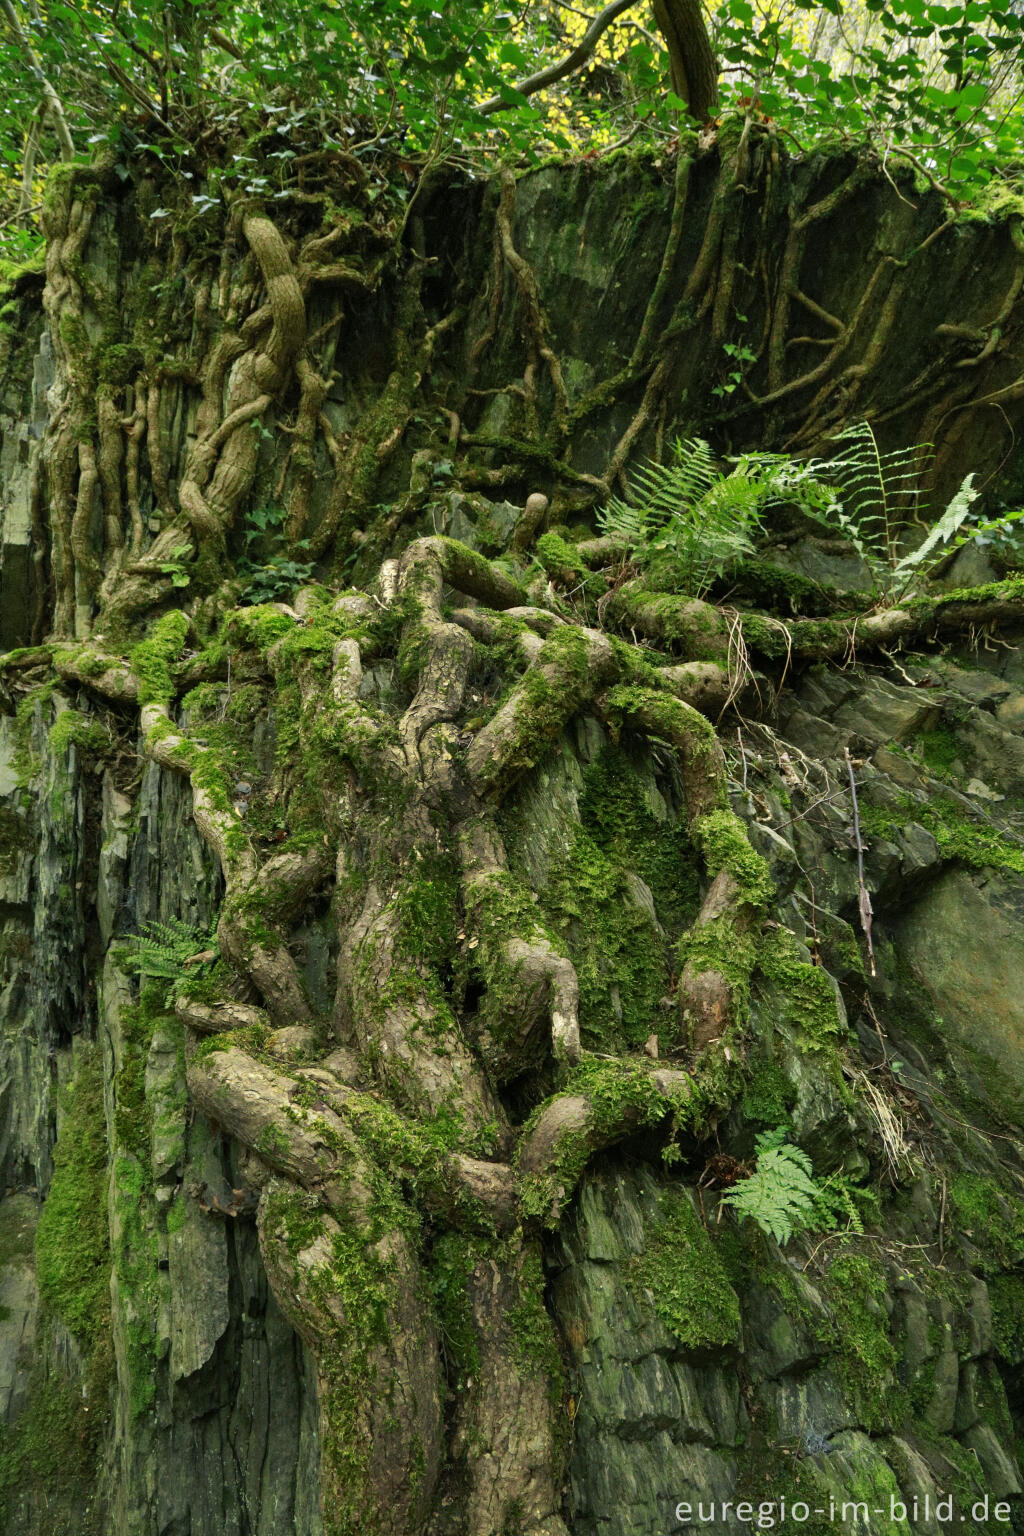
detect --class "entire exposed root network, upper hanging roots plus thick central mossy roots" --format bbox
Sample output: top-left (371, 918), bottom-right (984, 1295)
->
top-left (22, 144), bottom-right (1024, 1536)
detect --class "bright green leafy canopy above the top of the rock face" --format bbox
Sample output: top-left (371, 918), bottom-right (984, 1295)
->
top-left (0, 0), bottom-right (1024, 261)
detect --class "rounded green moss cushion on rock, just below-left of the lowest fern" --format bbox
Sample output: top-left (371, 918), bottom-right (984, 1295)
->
top-left (626, 1189), bottom-right (740, 1350)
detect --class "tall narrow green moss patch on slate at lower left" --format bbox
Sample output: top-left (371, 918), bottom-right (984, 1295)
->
top-left (35, 1046), bottom-right (111, 1347)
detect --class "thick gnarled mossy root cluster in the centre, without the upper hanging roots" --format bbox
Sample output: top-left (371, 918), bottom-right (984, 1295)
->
top-left (46, 525), bottom-right (792, 1536)
